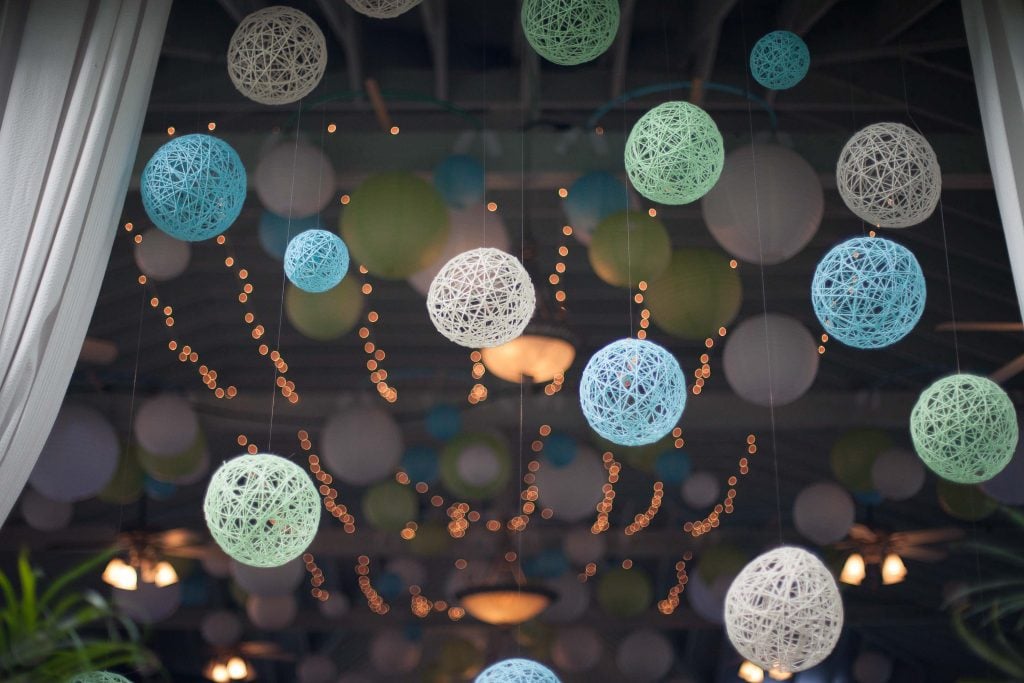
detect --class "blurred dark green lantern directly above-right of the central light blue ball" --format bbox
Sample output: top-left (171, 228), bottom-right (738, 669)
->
top-left (644, 249), bottom-right (743, 341)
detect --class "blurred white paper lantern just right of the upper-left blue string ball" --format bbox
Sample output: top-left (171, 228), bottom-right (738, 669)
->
top-left (253, 142), bottom-right (335, 219)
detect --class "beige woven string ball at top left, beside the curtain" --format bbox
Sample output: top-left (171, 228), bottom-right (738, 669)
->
top-left (227, 5), bottom-right (327, 104)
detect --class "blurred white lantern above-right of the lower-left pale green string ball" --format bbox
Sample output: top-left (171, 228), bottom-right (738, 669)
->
top-left (321, 405), bottom-right (406, 486)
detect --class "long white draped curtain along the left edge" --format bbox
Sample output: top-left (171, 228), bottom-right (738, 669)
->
top-left (0, 0), bottom-right (171, 524)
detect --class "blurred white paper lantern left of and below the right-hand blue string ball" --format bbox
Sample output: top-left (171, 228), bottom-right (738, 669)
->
top-left (722, 313), bottom-right (818, 405)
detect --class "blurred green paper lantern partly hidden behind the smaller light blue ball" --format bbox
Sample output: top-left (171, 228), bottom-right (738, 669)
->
top-left (285, 275), bottom-right (362, 342)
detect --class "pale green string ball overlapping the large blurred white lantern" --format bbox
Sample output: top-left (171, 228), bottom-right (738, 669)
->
top-left (626, 101), bottom-right (725, 204)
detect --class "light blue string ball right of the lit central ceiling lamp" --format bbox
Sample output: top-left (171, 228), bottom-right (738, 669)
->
top-left (580, 339), bottom-right (686, 445)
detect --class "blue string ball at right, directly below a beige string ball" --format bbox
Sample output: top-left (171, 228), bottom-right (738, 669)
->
top-left (811, 238), bottom-right (927, 348)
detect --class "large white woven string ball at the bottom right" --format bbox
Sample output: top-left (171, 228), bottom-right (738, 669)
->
top-left (725, 546), bottom-right (843, 673)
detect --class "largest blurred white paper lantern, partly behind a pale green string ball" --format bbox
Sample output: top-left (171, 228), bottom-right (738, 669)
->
top-left (700, 144), bottom-right (825, 265)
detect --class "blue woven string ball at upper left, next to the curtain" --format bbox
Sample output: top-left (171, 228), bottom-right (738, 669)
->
top-left (141, 134), bottom-right (246, 242)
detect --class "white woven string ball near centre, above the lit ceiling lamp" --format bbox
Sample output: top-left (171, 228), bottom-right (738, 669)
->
top-left (427, 247), bottom-right (537, 348)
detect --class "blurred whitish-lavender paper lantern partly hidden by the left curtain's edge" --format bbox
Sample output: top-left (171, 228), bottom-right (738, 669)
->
top-left (29, 403), bottom-right (121, 503)
